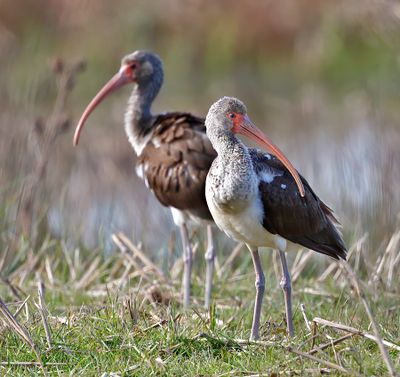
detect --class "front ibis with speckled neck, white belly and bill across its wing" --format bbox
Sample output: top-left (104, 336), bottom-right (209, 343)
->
top-left (205, 97), bottom-right (347, 339)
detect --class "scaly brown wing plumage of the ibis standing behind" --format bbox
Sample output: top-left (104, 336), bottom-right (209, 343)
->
top-left (137, 113), bottom-right (217, 220)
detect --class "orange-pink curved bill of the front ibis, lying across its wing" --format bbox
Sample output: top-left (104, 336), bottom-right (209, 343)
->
top-left (232, 115), bottom-right (305, 197)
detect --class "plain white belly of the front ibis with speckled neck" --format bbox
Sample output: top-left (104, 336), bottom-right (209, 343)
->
top-left (206, 192), bottom-right (280, 247)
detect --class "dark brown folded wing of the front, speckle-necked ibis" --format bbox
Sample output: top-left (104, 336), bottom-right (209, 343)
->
top-left (250, 149), bottom-right (347, 259)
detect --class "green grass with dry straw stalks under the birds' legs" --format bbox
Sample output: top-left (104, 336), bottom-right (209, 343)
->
top-left (0, 234), bottom-right (400, 376)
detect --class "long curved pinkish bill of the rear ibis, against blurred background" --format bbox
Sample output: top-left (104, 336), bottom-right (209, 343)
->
top-left (74, 66), bottom-right (133, 145)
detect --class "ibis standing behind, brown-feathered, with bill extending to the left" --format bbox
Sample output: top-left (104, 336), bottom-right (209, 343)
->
top-left (74, 51), bottom-right (216, 307)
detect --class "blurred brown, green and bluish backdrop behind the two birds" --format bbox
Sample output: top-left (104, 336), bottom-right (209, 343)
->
top-left (0, 0), bottom-right (400, 252)
